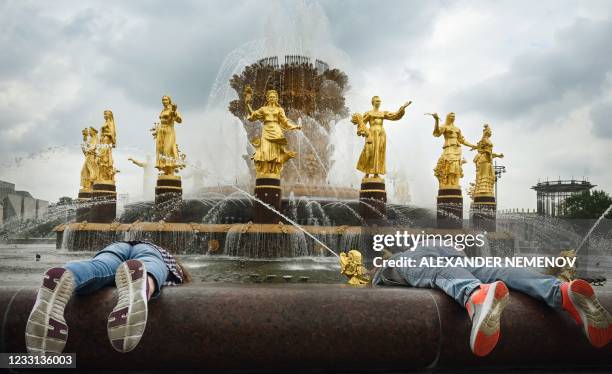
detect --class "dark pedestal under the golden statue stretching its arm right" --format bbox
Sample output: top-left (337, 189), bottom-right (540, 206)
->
top-left (359, 178), bottom-right (387, 224)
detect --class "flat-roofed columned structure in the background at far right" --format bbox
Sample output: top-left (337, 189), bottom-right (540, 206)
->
top-left (531, 179), bottom-right (595, 217)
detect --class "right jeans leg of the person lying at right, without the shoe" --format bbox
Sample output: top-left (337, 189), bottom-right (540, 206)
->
top-left (469, 267), bottom-right (562, 309)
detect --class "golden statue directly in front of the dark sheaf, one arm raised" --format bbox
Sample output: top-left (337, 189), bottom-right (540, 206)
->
top-left (244, 86), bottom-right (302, 178)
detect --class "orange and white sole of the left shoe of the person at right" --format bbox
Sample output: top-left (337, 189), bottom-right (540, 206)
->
top-left (470, 281), bottom-right (510, 356)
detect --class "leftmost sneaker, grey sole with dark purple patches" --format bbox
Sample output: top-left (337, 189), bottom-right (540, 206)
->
top-left (25, 268), bottom-right (74, 355)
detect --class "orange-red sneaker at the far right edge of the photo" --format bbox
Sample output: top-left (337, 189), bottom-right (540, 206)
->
top-left (561, 279), bottom-right (612, 348)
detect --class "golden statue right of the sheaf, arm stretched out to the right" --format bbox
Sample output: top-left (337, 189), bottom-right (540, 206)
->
top-left (351, 96), bottom-right (412, 178)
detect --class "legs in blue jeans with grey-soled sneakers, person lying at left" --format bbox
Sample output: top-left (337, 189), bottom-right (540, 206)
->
top-left (25, 243), bottom-right (168, 354)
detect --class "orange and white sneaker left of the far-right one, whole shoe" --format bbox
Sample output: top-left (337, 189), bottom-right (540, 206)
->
top-left (465, 281), bottom-right (510, 356)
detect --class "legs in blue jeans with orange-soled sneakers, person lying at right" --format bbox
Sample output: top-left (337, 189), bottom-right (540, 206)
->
top-left (372, 246), bottom-right (612, 356)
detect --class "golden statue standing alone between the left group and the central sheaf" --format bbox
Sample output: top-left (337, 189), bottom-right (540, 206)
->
top-left (151, 95), bottom-right (185, 176)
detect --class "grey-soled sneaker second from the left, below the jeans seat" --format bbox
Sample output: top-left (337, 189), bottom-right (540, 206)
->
top-left (106, 260), bottom-right (148, 353)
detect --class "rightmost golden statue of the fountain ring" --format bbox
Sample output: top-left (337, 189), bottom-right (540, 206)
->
top-left (472, 124), bottom-right (504, 196)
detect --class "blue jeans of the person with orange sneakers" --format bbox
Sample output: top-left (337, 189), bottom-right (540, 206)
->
top-left (372, 246), bottom-right (562, 309)
